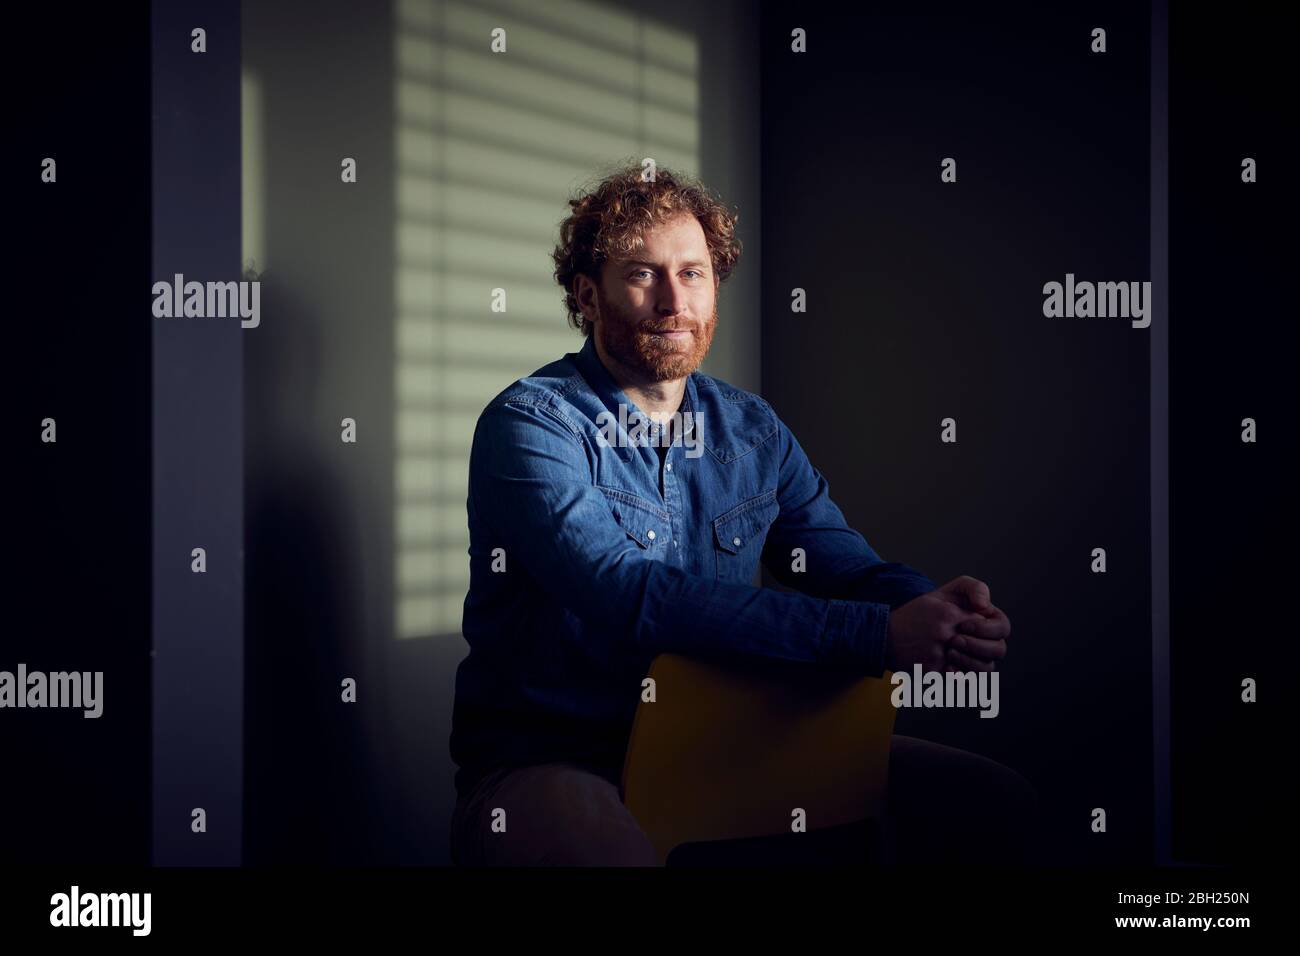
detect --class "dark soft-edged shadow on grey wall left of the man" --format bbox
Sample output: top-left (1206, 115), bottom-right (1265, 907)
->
top-left (244, 270), bottom-right (374, 865)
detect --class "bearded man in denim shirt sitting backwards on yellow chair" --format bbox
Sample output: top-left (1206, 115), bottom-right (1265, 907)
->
top-left (450, 166), bottom-right (1032, 865)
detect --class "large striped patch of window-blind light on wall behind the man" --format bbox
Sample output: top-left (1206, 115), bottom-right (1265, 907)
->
top-left (393, 0), bottom-right (699, 637)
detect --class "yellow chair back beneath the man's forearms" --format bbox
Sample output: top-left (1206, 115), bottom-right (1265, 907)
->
top-left (621, 654), bottom-right (897, 864)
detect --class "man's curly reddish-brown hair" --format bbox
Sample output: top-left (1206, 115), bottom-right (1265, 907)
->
top-left (551, 164), bottom-right (741, 336)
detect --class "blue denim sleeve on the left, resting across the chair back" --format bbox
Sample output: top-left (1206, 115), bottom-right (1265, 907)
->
top-left (469, 401), bottom-right (888, 675)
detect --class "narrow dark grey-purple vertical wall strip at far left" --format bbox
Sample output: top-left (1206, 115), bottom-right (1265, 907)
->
top-left (151, 0), bottom-right (245, 866)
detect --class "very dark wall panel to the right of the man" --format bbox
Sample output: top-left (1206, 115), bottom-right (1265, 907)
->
top-left (762, 4), bottom-right (1152, 864)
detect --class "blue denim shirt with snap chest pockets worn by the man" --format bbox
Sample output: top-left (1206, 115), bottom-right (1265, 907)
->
top-left (450, 337), bottom-right (936, 792)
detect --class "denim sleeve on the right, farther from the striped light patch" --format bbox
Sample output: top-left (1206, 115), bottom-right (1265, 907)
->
top-left (763, 412), bottom-right (937, 610)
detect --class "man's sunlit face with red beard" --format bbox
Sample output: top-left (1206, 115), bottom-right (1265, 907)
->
top-left (592, 215), bottom-right (718, 381)
